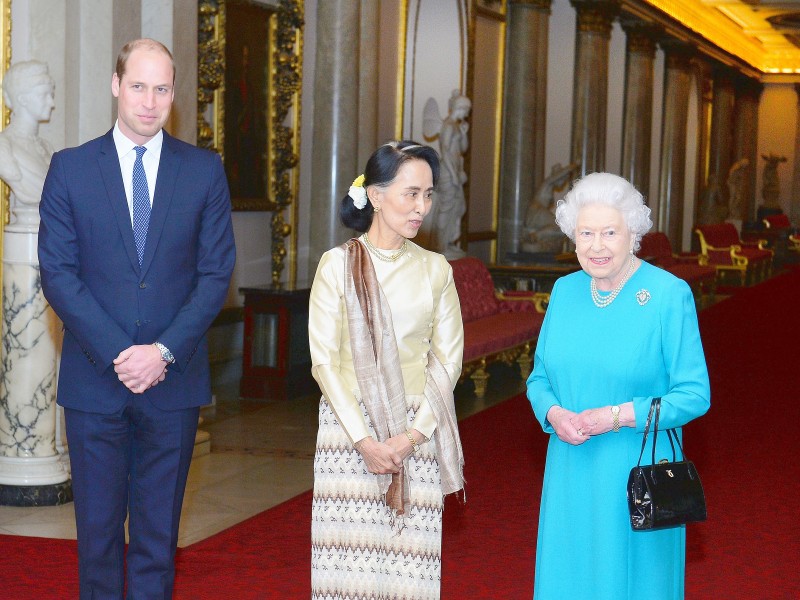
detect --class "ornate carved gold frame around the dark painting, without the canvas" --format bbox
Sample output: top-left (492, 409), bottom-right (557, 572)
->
top-left (197, 0), bottom-right (304, 284)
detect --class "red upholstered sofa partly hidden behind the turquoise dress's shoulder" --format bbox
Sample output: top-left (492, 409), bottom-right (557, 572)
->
top-left (638, 231), bottom-right (717, 305)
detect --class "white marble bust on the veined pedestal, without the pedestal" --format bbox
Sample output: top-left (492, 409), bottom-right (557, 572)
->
top-left (0, 60), bottom-right (55, 229)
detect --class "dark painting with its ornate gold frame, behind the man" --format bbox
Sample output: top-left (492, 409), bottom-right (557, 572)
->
top-left (197, 0), bottom-right (304, 283)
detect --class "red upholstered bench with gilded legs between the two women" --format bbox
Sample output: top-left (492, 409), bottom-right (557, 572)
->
top-left (450, 257), bottom-right (549, 398)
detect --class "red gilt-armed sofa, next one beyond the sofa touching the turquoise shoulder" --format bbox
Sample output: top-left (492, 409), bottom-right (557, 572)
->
top-left (695, 223), bottom-right (774, 285)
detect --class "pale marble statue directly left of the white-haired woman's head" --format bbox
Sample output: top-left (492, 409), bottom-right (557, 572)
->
top-left (520, 163), bottom-right (580, 254)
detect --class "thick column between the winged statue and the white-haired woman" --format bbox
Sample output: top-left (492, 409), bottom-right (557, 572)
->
top-left (497, 0), bottom-right (551, 263)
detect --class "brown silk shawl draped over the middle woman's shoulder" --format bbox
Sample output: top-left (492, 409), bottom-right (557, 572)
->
top-left (343, 238), bottom-right (464, 515)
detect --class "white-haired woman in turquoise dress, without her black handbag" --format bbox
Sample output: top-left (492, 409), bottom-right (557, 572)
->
top-left (527, 173), bottom-right (710, 600)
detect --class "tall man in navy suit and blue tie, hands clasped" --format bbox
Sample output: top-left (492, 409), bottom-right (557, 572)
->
top-left (39, 39), bottom-right (235, 600)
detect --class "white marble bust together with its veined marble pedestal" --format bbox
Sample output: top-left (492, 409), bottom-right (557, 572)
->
top-left (0, 60), bottom-right (71, 494)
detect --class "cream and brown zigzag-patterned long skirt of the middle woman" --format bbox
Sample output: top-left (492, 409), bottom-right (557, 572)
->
top-left (311, 395), bottom-right (444, 600)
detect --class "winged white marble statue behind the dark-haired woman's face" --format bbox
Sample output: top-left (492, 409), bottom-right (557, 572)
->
top-left (423, 90), bottom-right (472, 259)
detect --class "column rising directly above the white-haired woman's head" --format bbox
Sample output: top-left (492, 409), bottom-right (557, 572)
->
top-left (570, 0), bottom-right (620, 175)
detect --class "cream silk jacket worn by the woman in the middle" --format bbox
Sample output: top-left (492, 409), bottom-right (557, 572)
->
top-left (308, 241), bottom-right (464, 443)
